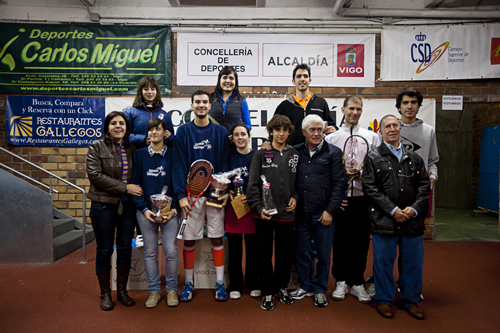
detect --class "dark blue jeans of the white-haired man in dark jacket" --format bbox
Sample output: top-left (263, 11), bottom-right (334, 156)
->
top-left (295, 213), bottom-right (335, 294)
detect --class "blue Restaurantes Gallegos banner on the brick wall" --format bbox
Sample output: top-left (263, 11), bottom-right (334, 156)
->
top-left (6, 96), bottom-right (105, 147)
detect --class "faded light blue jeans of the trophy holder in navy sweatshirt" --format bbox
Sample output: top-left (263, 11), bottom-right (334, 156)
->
top-left (137, 211), bottom-right (179, 293)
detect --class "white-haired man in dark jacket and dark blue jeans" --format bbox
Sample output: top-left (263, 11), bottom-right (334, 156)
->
top-left (290, 115), bottom-right (346, 307)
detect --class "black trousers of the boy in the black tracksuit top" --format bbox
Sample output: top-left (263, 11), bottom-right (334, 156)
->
top-left (255, 218), bottom-right (295, 296)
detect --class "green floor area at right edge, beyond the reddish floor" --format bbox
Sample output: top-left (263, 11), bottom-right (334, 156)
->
top-left (434, 208), bottom-right (500, 242)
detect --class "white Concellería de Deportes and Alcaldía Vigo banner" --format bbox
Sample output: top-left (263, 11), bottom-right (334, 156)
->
top-left (177, 32), bottom-right (375, 87)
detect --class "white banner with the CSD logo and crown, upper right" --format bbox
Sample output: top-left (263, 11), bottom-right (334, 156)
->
top-left (380, 23), bottom-right (500, 81)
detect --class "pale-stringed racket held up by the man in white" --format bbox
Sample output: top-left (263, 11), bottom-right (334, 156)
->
top-left (342, 135), bottom-right (370, 200)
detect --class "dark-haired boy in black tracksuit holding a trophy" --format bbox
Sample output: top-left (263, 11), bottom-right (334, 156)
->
top-left (247, 115), bottom-right (299, 310)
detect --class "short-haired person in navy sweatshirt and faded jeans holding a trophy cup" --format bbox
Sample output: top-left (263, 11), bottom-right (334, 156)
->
top-left (131, 118), bottom-right (179, 309)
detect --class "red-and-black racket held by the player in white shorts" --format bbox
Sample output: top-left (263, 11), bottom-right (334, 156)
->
top-left (177, 160), bottom-right (213, 239)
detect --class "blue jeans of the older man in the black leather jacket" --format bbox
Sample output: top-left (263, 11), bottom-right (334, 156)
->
top-left (372, 234), bottom-right (424, 307)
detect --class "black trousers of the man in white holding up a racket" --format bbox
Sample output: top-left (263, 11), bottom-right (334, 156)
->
top-left (332, 196), bottom-right (370, 287)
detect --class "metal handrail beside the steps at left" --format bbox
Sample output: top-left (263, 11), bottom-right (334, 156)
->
top-left (0, 147), bottom-right (87, 264)
